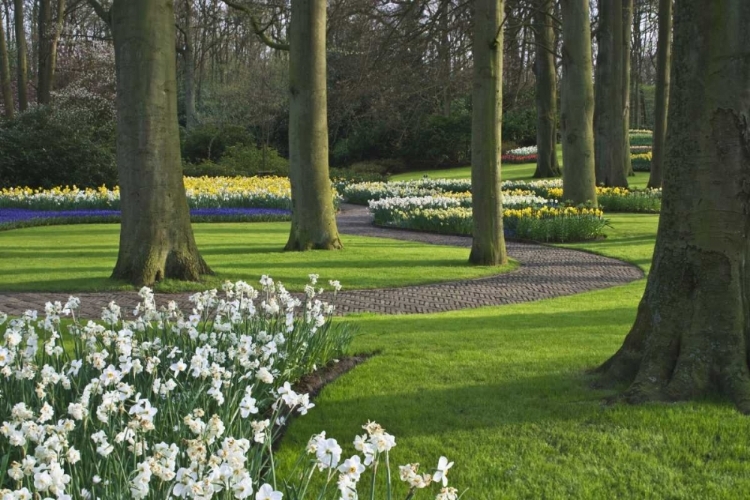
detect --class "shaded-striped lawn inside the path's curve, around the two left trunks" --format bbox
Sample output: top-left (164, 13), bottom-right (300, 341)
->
top-left (0, 222), bottom-right (516, 292)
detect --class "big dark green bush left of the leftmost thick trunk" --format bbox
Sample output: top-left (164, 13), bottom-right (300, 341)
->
top-left (0, 102), bottom-right (117, 188)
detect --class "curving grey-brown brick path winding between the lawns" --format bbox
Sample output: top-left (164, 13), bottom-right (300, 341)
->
top-left (0, 205), bottom-right (643, 318)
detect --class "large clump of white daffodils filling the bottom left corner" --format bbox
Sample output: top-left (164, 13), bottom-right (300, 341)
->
top-left (0, 276), bottom-right (350, 500)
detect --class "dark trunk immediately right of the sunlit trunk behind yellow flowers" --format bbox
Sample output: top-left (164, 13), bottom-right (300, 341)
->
top-left (596, 0), bottom-right (630, 187)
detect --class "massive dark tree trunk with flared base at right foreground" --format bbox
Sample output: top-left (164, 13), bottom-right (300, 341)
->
top-left (598, 0), bottom-right (750, 413)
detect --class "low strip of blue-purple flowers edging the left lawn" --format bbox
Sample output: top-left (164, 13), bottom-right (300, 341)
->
top-left (0, 208), bottom-right (290, 230)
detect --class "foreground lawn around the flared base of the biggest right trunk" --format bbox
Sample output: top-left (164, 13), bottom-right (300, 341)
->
top-left (277, 214), bottom-right (750, 500)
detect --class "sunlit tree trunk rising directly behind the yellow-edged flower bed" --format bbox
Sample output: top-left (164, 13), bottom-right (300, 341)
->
top-left (560, 0), bottom-right (596, 205)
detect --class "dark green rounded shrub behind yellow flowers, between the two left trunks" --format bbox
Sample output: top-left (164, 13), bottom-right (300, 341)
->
top-left (182, 124), bottom-right (254, 164)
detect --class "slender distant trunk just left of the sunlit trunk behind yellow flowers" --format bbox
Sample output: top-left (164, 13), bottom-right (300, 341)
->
top-left (534, 0), bottom-right (560, 179)
